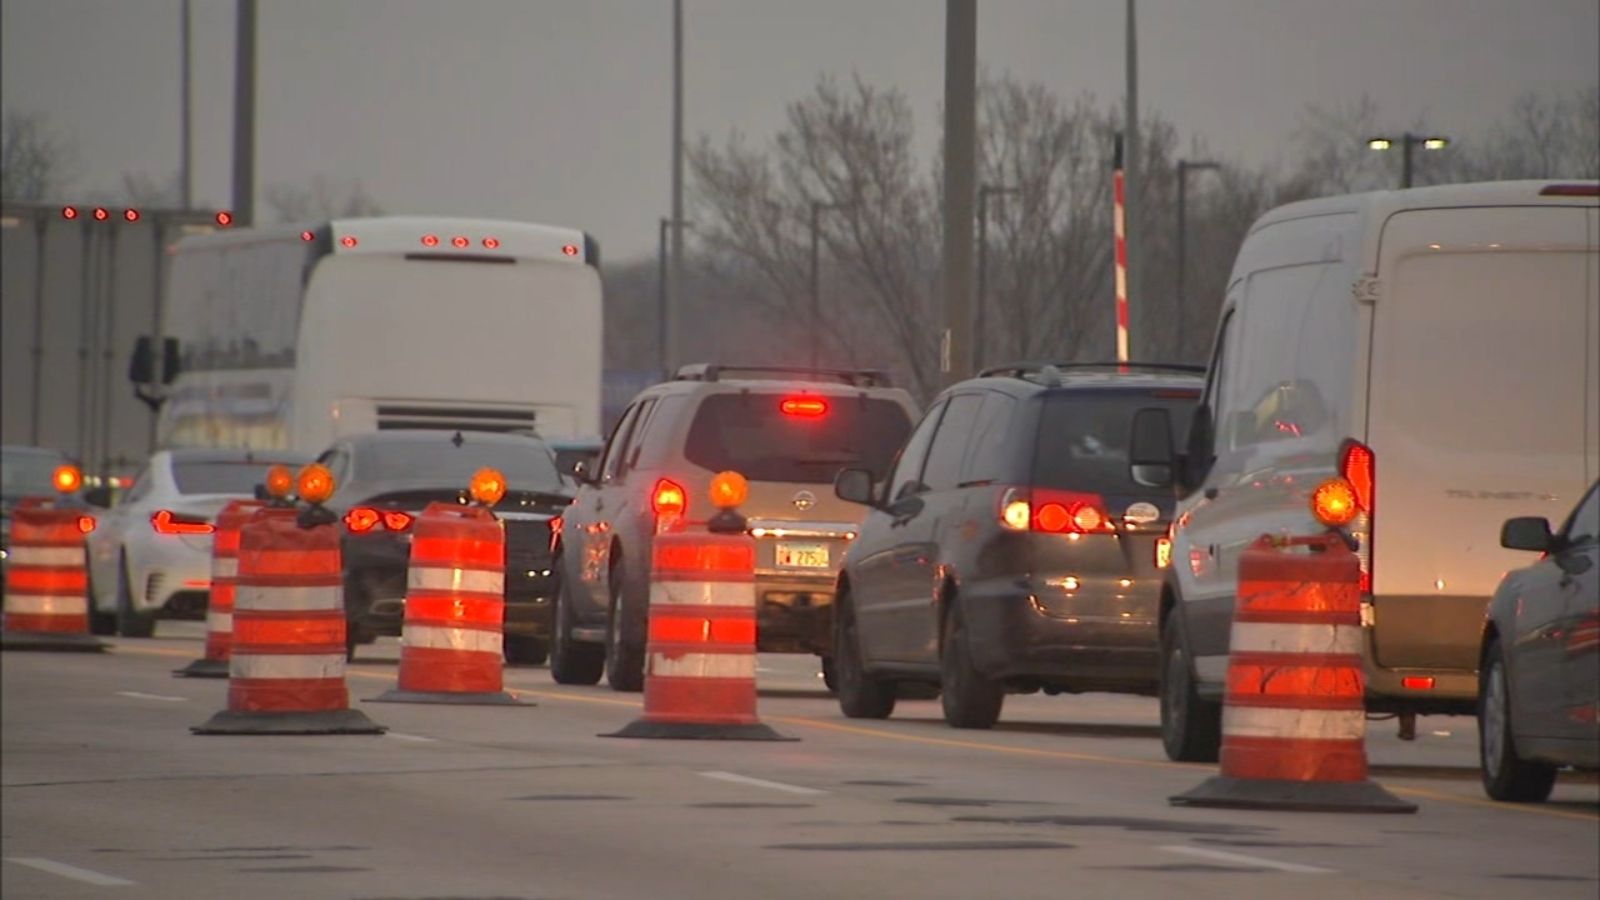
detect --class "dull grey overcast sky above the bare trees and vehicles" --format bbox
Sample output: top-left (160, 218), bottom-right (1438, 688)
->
top-left (0, 0), bottom-right (1600, 259)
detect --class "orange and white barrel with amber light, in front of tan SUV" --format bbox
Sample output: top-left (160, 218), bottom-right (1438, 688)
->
top-left (605, 472), bottom-right (792, 740)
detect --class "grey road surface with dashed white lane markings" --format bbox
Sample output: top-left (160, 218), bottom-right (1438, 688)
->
top-left (0, 623), bottom-right (1600, 900)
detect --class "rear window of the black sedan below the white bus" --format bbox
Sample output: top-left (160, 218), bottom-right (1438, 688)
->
top-left (352, 439), bottom-right (563, 492)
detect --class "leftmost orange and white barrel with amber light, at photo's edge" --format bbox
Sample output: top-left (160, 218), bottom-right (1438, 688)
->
top-left (0, 466), bottom-right (106, 652)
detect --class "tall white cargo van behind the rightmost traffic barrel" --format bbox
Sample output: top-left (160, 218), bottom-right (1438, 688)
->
top-left (1146, 181), bottom-right (1600, 759)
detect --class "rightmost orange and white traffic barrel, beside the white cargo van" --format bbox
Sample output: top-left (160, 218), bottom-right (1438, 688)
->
top-left (1171, 533), bottom-right (1416, 812)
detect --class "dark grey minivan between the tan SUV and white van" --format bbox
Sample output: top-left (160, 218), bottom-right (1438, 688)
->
top-left (834, 364), bottom-right (1202, 729)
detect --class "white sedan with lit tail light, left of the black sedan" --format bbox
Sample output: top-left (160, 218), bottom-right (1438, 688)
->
top-left (86, 450), bottom-right (309, 637)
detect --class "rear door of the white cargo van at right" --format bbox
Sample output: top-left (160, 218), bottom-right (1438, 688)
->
top-left (1366, 205), bottom-right (1594, 671)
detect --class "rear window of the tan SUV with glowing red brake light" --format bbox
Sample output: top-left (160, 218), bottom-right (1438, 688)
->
top-left (683, 392), bottom-right (910, 484)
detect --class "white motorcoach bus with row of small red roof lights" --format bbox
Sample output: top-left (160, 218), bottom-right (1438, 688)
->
top-left (131, 216), bottom-right (602, 453)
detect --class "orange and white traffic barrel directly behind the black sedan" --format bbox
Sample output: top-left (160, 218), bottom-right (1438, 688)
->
top-left (373, 503), bottom-right (522, 705)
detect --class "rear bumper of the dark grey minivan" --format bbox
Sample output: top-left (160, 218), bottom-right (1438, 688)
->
top-left (962, 570), bottom-right (1160, 693)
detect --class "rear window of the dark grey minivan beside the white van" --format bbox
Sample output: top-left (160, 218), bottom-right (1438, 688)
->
top-left (1034, 389), bottom-right (1200, 495)
